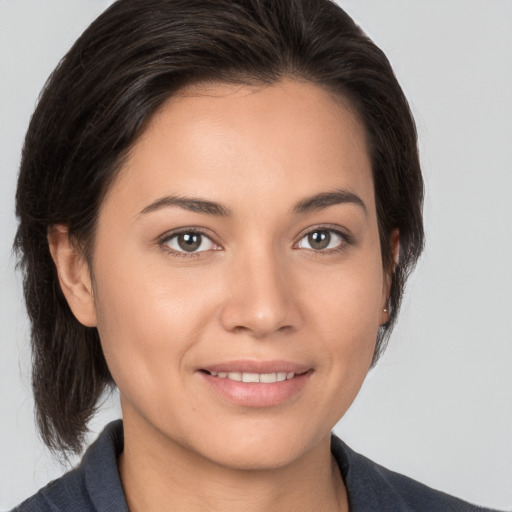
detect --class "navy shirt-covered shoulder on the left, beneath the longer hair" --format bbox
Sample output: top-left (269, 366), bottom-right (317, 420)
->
top-left (11, 421), bottom-right (128, 512)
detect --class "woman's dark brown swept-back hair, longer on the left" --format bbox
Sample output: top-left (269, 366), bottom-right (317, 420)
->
top-left (15, 0), bottom-right (423, 452)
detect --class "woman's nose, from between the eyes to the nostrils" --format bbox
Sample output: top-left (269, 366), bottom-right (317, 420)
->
top-left (221, 246), bottom-right (302, 338)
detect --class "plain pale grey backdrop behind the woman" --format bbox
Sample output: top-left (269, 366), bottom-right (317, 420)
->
top-left (0, 0), bottom-right (512, 510)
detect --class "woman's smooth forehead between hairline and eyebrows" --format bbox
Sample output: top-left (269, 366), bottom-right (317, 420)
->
top-left (106, 80), bottom-right (374, 218)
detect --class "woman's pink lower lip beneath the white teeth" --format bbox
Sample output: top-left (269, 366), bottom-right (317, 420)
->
top-left (199, 372), bottom-right (311, 407)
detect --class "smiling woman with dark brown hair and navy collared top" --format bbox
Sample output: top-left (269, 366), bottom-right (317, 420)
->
top-left (10, 0), bottom-right (506, 511)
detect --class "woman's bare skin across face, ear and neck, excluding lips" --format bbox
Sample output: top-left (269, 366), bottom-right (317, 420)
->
top-left (49, 80), bottom-right (397, 512)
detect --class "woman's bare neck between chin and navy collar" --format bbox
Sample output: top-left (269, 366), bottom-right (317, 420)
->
top-left (119, 414), bottom-right (348, 512)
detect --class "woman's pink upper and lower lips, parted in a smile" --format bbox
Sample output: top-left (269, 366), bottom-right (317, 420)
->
top-left (197, 360), bottom-right (313, 407)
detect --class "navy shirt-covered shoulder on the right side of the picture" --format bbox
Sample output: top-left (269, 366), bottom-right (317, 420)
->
top-left (331, 435), bottom-right (504, 512)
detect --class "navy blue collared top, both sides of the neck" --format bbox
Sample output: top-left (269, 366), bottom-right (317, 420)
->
top-left (11, 420), bottom-right (504, 512)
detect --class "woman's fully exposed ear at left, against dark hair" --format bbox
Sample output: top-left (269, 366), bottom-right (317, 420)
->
top-left (48, 224), bottom-right (96, 327)
